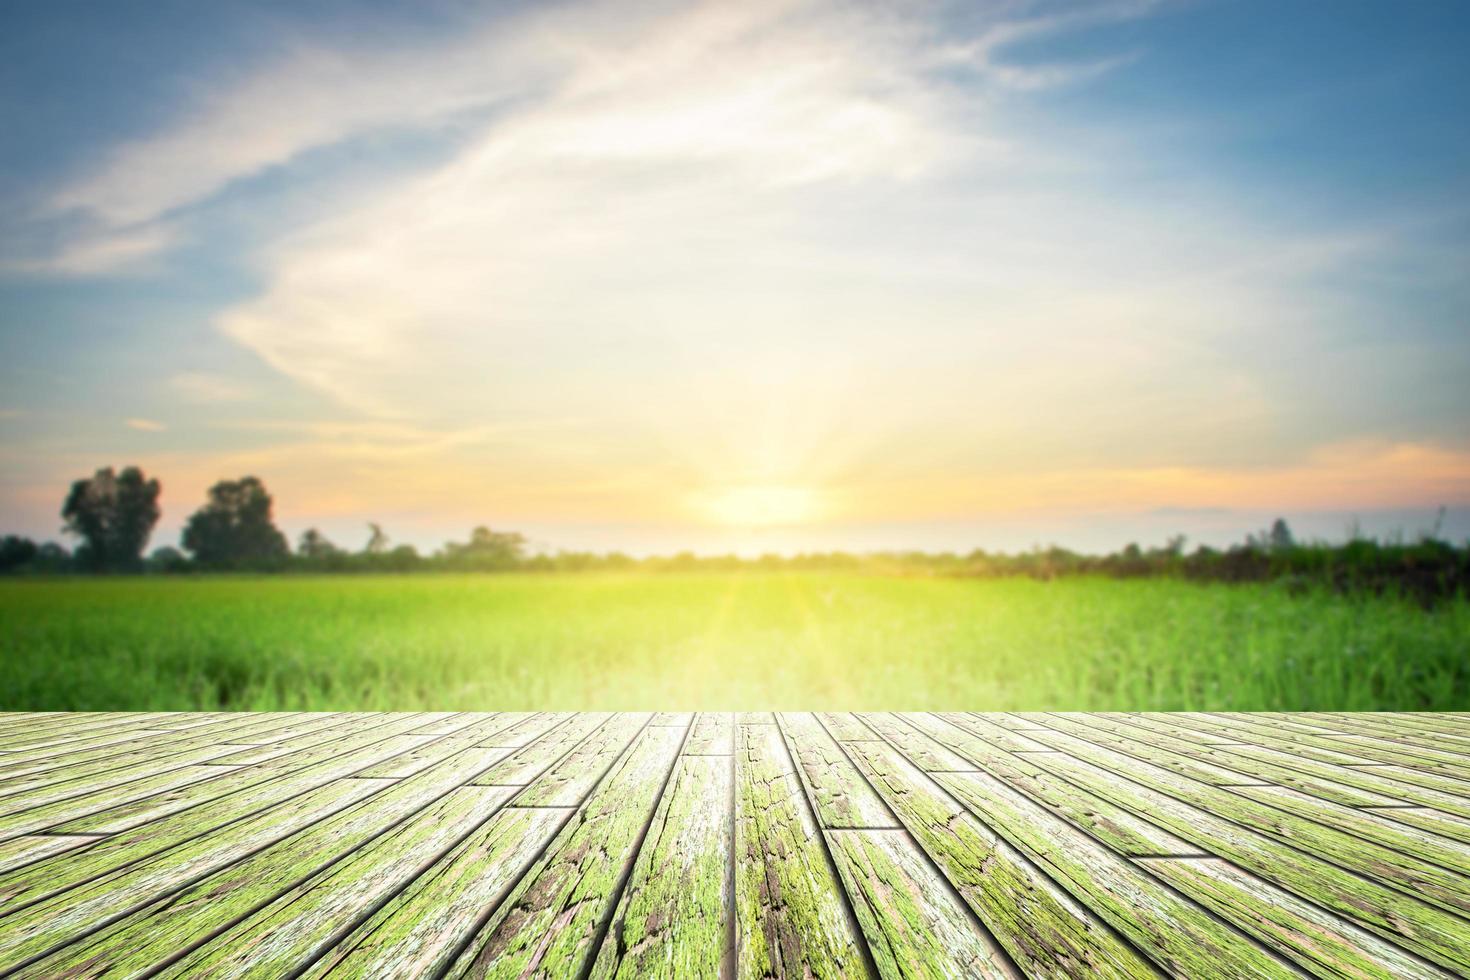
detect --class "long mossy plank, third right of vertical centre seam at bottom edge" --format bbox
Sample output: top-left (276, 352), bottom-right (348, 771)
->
top-left (851, 742), bottom-right (1157, 977)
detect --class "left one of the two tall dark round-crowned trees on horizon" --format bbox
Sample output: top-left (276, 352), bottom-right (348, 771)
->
top-left (62, 466), bottom-right (162, 572)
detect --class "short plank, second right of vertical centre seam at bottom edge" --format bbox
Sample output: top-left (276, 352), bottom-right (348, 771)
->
top-left (823, 830), bottom-right (1020, 980)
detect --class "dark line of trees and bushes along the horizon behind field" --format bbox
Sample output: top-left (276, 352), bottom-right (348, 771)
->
top-left (0, 467), bottom-right (1470, 602)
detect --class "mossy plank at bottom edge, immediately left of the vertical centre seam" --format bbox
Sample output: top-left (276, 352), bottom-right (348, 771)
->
top-left (591, 758), bottom-right (735, 980)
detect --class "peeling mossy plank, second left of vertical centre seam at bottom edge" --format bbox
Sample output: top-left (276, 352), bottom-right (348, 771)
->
top-left (447, 726), bottom-right (688, 977)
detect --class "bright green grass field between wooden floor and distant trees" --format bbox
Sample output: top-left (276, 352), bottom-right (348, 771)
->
top-left (0, 572), bottom-right (1470, 711)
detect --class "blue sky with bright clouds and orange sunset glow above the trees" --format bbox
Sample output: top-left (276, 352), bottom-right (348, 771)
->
top-left (0, 0), bottom-right (1470, 552)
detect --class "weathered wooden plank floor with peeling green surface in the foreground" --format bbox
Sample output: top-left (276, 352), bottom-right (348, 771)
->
top-left (0, 713), bottom-right (1470, 979)
